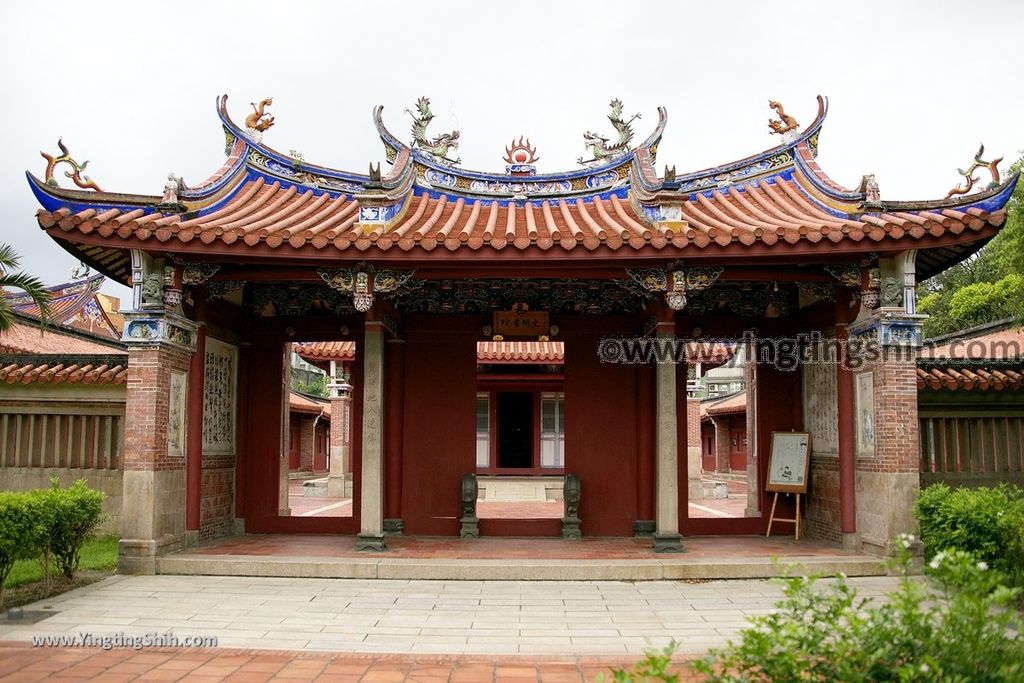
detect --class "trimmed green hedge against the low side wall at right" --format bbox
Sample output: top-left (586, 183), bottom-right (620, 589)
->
top-left (914, 483), bottom-right (1024, 585)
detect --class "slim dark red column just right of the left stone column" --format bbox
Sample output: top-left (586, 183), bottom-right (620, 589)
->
top-left (384, 339), bottom-right (406, 533)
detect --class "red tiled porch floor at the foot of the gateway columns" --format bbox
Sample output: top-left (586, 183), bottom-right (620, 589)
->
top-left (188, 533), bottom-right (855, 561)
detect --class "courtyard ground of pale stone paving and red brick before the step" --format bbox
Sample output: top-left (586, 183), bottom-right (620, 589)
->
top-left (0, 575), bottom-right (897, 681)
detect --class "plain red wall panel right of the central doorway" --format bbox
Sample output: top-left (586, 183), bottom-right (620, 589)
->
top-left (559, 317), bottom-right (639, 536)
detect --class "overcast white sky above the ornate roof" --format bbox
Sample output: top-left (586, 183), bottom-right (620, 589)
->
top-left (0, 0), bottom-right (1024, 294)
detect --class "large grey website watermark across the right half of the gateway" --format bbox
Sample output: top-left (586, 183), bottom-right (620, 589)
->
top-left (597, 332), bottom-right (1024, 371)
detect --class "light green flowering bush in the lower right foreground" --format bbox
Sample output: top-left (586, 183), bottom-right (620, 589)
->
top-left (694, 537), bottom-right (1024, 683)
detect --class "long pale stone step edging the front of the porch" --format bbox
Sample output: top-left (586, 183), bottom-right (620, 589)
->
top-left (157, 552), bottom-right (886, 581)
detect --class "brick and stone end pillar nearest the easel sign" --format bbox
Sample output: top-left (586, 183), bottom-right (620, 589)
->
top-left (850, 308), bottom-right (925, 555)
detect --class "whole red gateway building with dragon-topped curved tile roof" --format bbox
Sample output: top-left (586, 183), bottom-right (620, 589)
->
top-left (29, 96), bottom-right (1017, 571)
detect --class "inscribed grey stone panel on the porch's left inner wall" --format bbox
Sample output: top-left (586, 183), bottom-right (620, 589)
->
top-left (203, 337), bottom-right (239, 455)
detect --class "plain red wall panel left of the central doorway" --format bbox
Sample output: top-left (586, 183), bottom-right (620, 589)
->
top-left (401, 315), bottom-right (483, 536)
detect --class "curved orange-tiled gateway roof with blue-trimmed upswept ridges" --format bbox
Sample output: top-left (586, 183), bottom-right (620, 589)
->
top-left (30, 94), bottom-right (1017, 280)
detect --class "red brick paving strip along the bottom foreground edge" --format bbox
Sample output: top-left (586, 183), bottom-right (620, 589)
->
top-left (0, 643), bottom-right (700, 683)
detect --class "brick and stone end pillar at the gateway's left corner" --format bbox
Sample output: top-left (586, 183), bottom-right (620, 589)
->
top-left (118, 310), bottom-right (196, 573)
